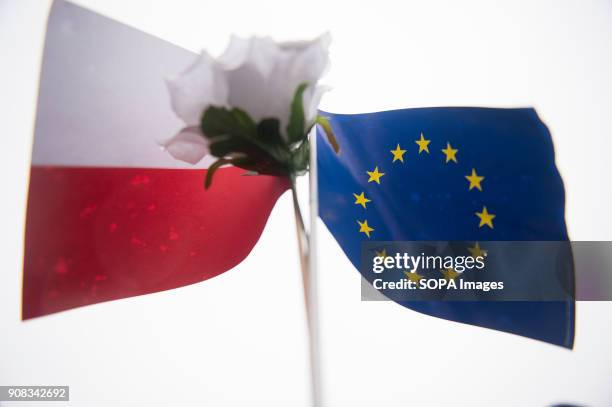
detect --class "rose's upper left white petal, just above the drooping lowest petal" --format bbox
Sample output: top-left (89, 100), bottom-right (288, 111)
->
top-left (166, 51), bottom-right (228, 126)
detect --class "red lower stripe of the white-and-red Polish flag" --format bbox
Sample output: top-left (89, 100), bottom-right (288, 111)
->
top-left (22, 166), bottom-right (288, 319)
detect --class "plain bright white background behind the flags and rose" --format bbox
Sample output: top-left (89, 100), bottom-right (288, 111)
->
top-left (0, 0), bottom-right (612, 407)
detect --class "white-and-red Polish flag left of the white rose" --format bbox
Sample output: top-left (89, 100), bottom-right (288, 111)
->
top-left (22, 1), bottom-right (288, 319)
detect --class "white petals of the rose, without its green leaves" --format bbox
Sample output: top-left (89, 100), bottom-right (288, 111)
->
top-left (164, 34), bottom-right (330, 164)
